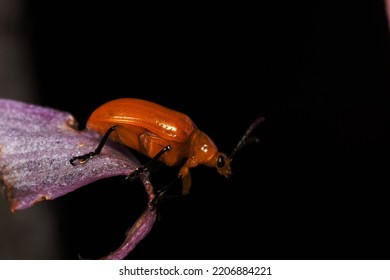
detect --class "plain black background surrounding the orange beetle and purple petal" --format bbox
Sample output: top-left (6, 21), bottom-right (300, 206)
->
top-left (22, 1), bottom-right (390, 259)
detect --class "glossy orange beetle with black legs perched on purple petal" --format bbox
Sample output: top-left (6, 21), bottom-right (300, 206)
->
top-left (70, 98), bottom-right (264, 194)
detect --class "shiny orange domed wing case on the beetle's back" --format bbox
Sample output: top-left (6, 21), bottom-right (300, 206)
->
top-left (87, 98), bottom-right (195, 144)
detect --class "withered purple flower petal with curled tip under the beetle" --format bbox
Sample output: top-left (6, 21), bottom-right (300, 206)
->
top-left (0, 99), bottom-right (156, 259)
